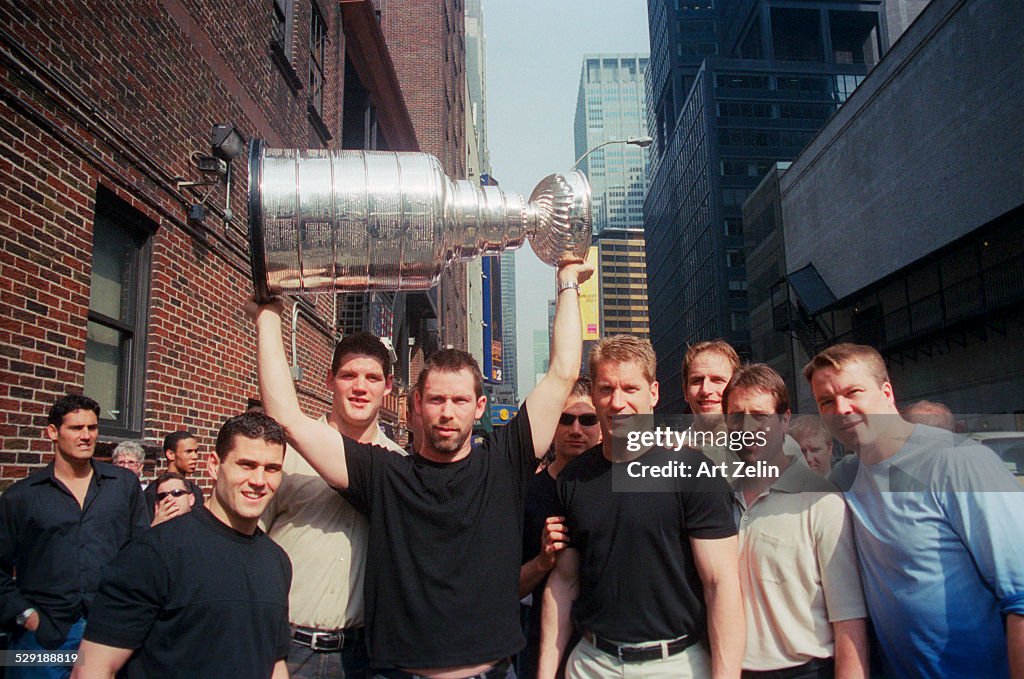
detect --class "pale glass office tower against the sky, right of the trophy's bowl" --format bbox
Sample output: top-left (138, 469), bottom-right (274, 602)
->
top-left (573, 54), bottom-right (647, 236)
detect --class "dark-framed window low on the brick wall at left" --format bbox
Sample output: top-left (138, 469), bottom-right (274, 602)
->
top-left (85, 188), bottom-right (155, 436)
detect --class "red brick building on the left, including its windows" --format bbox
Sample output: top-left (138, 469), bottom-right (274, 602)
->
top-left (0, 0), bottom-right (425, 487)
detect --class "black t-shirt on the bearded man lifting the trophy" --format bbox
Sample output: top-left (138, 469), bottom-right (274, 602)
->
top-left (342, 408), bottom-right (537, 669)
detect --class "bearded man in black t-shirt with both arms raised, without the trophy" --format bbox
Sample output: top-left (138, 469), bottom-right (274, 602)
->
top-left (247, 262), bottom-right (593, 678)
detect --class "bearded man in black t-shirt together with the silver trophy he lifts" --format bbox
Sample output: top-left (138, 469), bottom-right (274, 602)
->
top-left (246, 141), bottom-right (593, 679)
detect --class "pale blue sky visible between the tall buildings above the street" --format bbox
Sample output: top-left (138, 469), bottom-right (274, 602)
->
top-left (483, 0), bottom-right (650, 398)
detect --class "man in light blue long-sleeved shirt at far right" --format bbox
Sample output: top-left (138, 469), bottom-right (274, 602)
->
top-left (804, 344), bottom-right (1024, 678)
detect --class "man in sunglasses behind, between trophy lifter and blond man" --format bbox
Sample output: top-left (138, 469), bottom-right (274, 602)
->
top-left (516, 377), bottom-right (601, 679)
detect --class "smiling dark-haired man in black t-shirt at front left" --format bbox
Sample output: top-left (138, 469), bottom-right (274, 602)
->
top-left (72, 412), bottom-right (292, 679)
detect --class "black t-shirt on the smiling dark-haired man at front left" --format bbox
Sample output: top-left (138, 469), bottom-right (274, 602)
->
top-left (84, 507), bottom-right (292, 679)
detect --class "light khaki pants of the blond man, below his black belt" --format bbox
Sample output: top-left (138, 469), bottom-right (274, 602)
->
top-left (565, 639), bottom-right (711, 679)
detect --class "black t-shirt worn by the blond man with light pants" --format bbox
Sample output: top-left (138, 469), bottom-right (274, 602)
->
top-left (557, 444), bottom-right (736, 643)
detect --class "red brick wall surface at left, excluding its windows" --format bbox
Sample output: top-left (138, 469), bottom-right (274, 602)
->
top-left (0, 0), bottom-right (344, 486)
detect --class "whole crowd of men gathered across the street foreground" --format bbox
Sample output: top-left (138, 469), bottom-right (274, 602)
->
top-left (0, 262), bottom-right (1024, 679)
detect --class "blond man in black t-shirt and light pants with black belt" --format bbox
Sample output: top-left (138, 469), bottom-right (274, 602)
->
top-left (538, 335), bottom-right (745, 678)
